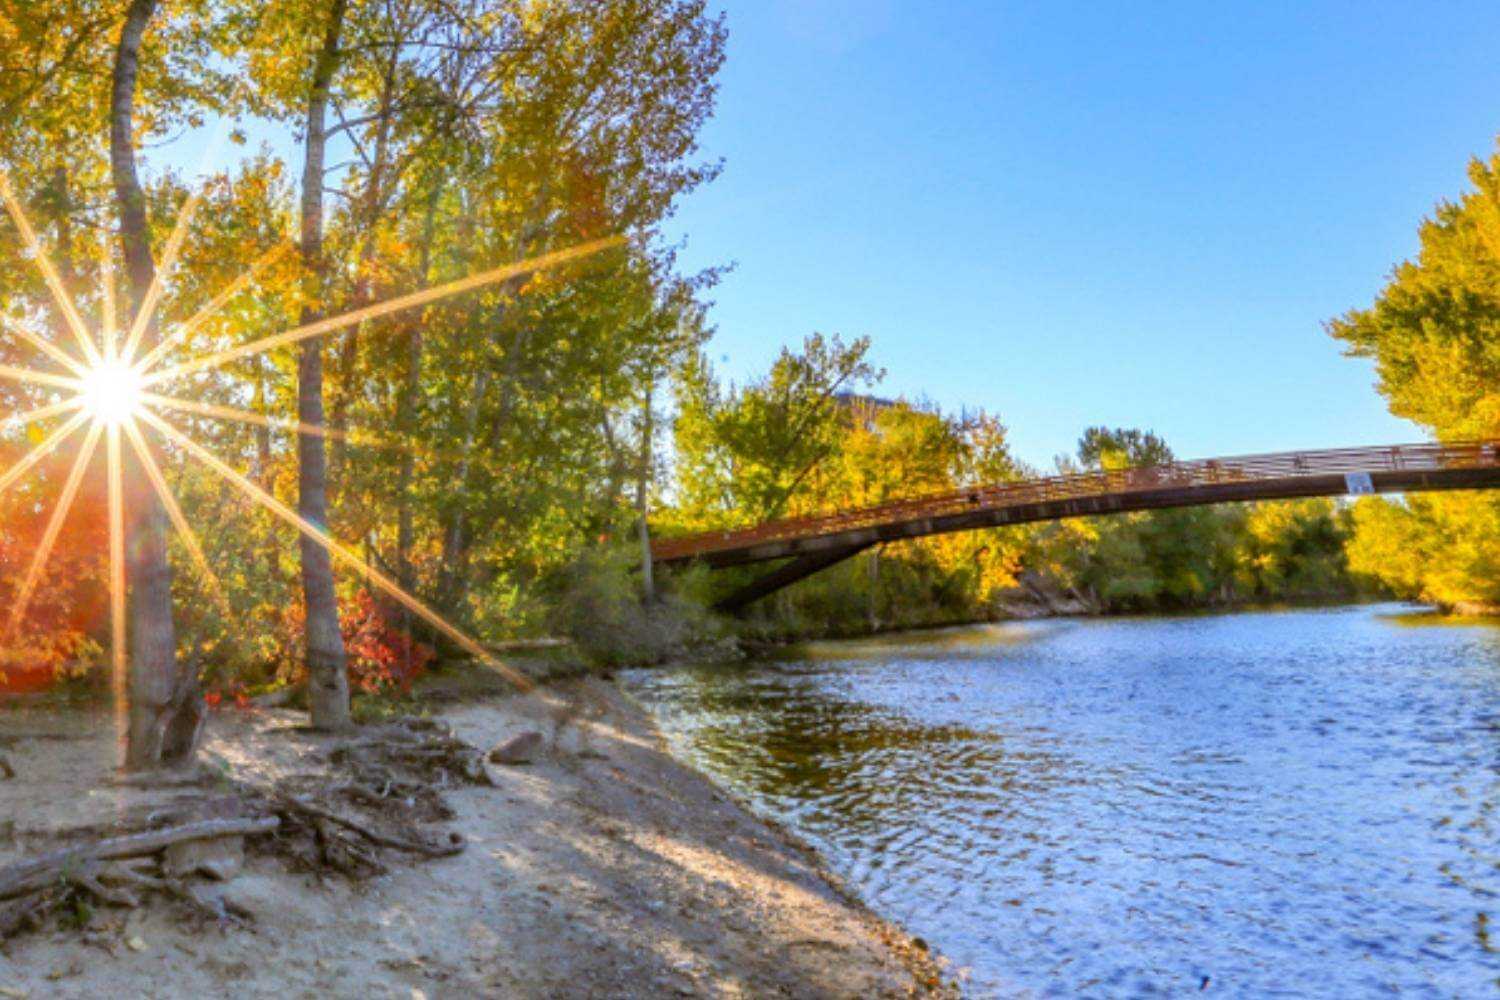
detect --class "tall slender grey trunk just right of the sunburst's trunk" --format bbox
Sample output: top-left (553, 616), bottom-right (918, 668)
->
top-left (297, 0), bottom-right (350, 730)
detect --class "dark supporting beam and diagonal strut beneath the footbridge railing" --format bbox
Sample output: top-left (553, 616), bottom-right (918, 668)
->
top-left (684, 466), bottom-right (1500, 613)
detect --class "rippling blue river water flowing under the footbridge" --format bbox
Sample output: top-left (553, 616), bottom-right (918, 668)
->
top-left (624, 606), bottom-right (1500, 997)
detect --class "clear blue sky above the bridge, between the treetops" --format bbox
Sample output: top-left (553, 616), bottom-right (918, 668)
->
top-left (674, 0), bottom-right (1500, 465)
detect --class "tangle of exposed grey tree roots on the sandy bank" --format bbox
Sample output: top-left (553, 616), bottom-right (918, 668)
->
top-left (0, 718), bottom-right (492, 940)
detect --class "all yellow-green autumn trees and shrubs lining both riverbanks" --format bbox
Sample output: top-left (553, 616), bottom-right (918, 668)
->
top-left (0, 0), bottom-right (1500, 743)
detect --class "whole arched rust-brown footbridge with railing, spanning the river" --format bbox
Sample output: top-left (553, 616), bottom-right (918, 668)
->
top-left (651, 441), bottom-right (1500, 612)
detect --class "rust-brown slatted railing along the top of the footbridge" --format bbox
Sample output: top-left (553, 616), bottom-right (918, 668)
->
top-left (651, 441), bottom-right (1500, 559)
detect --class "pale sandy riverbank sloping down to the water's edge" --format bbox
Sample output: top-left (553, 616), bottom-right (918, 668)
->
top-left (0, 681), bottom-right (954, 999)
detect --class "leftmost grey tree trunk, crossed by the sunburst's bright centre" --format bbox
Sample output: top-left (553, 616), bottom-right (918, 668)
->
top-left (110, 0), bottom-right (204, 771)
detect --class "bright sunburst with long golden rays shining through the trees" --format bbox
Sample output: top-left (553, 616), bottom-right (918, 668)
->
top-left (0, 171), bottom-right (624, 711)
